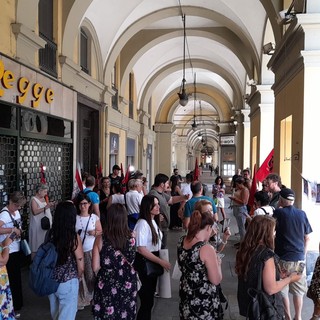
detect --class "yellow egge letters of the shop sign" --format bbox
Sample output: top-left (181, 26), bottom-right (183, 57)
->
top-left (0, 60), bottom-right (54, 108)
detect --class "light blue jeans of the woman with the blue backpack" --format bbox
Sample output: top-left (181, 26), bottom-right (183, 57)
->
top-left (49, 278), bottom-right (79, 320)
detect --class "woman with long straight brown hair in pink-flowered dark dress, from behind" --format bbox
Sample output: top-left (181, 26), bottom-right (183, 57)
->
top-left (92, 203), bottom-right (137, 320)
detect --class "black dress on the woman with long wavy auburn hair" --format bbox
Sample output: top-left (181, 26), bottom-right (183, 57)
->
top-left (237, 246), bottom-right (284, 320)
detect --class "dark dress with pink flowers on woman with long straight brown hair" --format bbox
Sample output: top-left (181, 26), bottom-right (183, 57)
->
top-left (93, 238), bottom-right (137, 320)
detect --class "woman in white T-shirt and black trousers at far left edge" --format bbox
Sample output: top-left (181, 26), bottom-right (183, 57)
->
top-left (0, 191), bottom-right (26, 318)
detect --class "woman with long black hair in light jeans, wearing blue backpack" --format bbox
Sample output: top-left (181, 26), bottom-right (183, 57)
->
top-left (48, 201), bottom-right (84, 320)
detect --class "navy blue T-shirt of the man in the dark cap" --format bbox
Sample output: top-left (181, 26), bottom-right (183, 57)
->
top-left (273, 206), bottom-right (312, 261)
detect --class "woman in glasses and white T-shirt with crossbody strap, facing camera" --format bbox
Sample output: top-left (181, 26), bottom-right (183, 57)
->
top-left (76, 194), bottom-right (102, 310)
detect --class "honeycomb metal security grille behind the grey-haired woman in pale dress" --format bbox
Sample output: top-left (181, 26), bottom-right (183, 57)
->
top-left (19, 138), bottom-right (72, 205)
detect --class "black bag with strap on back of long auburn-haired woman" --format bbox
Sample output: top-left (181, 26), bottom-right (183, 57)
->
top-left (246, 252), bottom-right (279, 320)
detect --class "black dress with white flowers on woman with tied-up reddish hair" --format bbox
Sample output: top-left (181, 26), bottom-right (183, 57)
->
top-left (178, 236), bottom-right (222, 320)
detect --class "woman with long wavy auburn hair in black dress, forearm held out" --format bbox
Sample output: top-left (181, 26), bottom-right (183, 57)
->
top-left (235, 215), bottom-right (301, 320)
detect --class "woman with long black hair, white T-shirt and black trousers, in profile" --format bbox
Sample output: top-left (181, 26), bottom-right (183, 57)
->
top-left (134, 195), bottom-right (171, 320)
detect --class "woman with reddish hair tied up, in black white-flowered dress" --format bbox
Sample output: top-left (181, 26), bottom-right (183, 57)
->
top-left (178, 210), bottom-right (222, 320)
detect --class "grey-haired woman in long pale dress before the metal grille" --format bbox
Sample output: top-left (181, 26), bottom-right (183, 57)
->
top-left (29, 183), bottom-right (54, 258)
